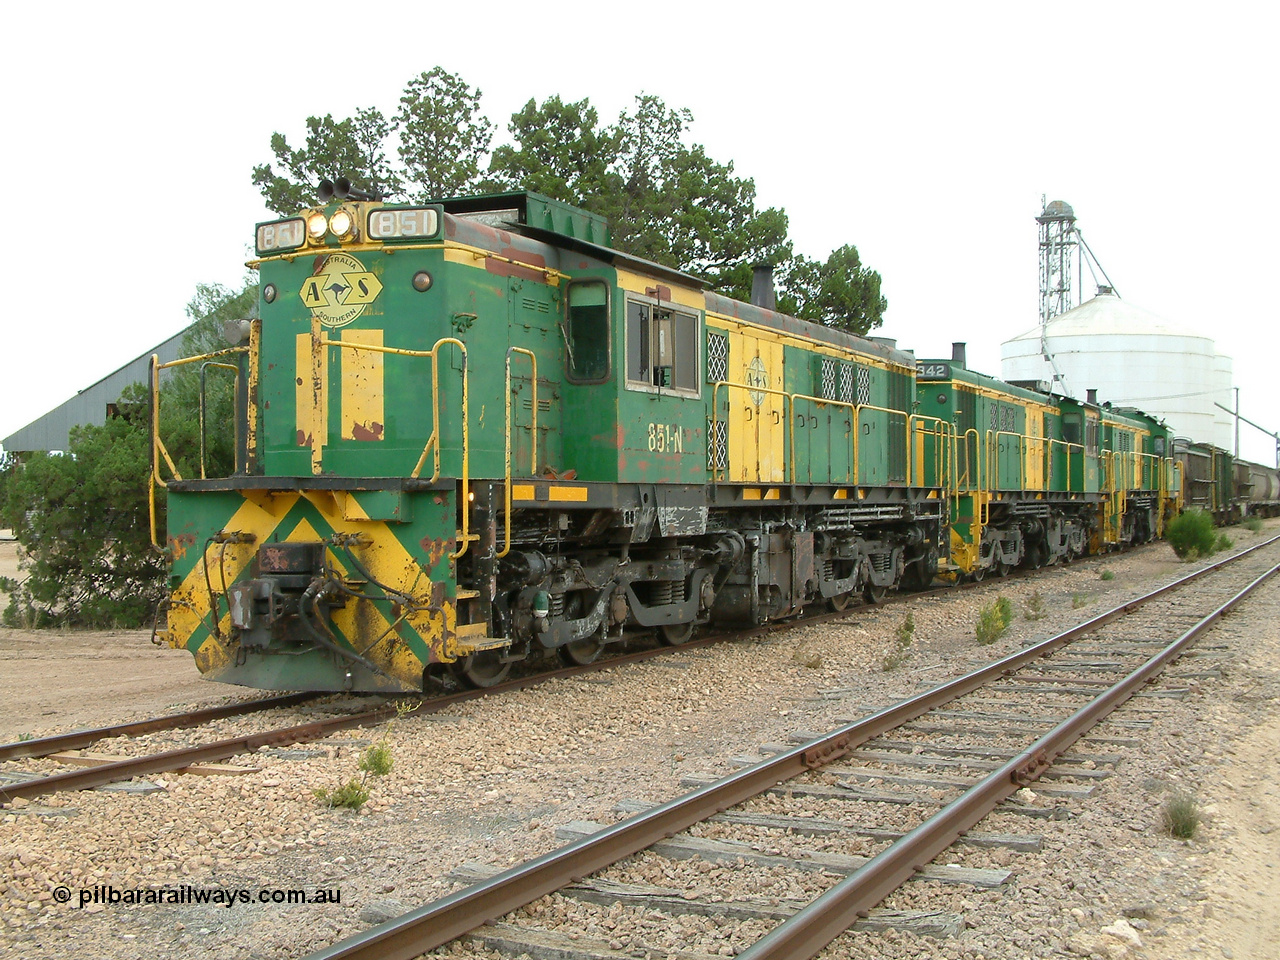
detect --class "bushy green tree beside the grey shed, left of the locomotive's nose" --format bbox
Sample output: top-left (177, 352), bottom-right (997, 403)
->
top-left (0, 280), bottom-right (257, 626)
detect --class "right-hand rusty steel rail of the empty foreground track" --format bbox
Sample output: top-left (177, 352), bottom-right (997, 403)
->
top-left (737, 564), bottom-right (1280, 960)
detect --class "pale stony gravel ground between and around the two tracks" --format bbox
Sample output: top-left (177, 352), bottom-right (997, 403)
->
top-left (0, 524), bottom-right (1280, 960)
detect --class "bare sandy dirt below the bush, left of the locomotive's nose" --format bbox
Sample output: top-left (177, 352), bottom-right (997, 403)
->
top-left (0, 540), bottom-right (250, 742)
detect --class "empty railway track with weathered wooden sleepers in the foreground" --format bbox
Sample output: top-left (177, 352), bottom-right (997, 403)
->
top-left (294, 539), bottom-right (1280, 960)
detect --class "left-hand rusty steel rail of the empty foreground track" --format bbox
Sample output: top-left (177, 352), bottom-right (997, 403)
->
top-left (293, 536), bottom-right (1280, 960)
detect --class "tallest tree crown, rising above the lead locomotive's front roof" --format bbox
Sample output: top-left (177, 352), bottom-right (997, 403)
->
top-left (396, 67), bottom-right (494, 201)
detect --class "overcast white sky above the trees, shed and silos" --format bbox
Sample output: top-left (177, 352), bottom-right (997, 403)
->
top-left (0, 0), bottom-right (1280, 462)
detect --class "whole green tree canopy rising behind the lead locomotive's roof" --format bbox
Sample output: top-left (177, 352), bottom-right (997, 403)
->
top-left (253, 67), bottom-right (887, 334)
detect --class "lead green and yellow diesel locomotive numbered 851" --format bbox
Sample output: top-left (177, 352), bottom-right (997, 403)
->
top-left (152, 192), bottom-right (952, 691)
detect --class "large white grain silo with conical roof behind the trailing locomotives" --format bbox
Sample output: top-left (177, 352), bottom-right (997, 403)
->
top-left (1001, 287), bottom-right (1231, 449)
